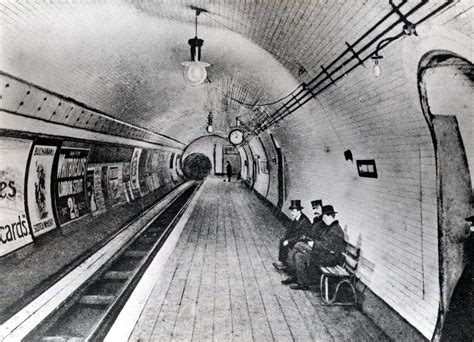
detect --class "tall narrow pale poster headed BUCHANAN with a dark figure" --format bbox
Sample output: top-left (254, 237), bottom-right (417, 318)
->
top-left (27, 145), bottom-right (57, 236)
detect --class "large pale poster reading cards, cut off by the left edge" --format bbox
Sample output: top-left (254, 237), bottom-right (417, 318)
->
top-left (0, 137), bottom-right (33, 256)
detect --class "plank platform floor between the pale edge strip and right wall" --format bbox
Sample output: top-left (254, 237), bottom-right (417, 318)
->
top-left (130, 178), bottom-right (388, 341)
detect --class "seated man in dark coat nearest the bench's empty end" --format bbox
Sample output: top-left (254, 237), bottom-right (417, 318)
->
top-left (286, 205), bottom-right (345, 290)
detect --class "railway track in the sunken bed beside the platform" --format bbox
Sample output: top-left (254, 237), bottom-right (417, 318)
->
top-left (24, 184), bottom-right (199, 342)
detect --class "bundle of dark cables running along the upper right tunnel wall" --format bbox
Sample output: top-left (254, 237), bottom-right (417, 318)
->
top-left (259, 0), bottom-right (454, 131)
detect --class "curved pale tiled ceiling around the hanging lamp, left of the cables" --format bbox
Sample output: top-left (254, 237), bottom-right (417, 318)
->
top-left (0, 0), bottom-right (466, 143)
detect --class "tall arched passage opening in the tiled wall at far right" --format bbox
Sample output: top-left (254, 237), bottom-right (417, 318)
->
top-left (418, 50), bottom-right (474, 340)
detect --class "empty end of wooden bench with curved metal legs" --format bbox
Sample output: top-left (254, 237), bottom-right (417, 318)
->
top-left (320, 241), bottom-right (360, 305)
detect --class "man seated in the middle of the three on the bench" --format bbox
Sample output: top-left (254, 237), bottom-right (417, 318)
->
top-left (283, 200), bottom-right (326, 276)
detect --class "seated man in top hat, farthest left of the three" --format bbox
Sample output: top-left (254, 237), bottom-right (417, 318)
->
top-left (273, 200), bottom-right (311, 270)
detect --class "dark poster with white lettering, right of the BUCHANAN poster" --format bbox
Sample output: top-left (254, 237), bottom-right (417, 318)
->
top-left (56, 148), bottom-right (89, 224)
